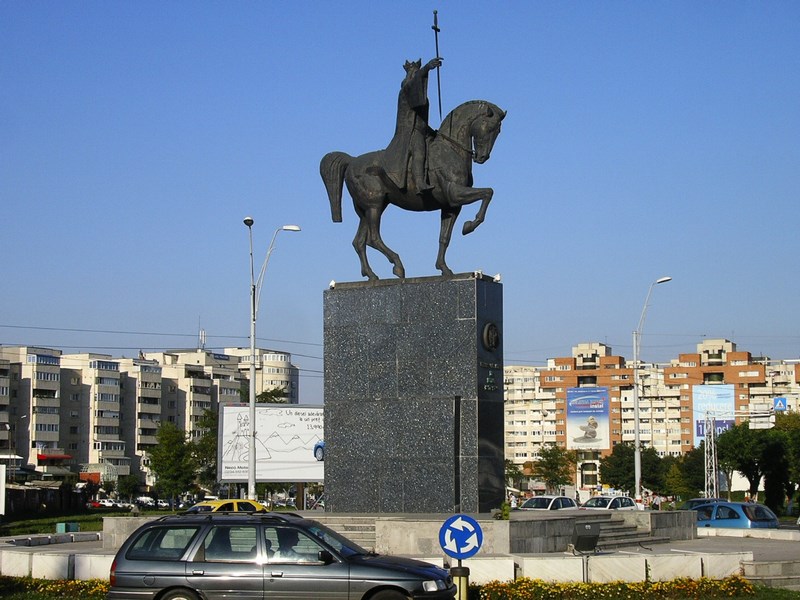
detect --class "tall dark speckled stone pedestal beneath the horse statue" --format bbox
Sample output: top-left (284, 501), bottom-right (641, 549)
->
top-left (324, 273), bottom-right (505, 513)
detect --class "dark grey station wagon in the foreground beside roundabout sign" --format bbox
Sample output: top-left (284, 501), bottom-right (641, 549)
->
top-left (106, 513), bottom-right (456, 600)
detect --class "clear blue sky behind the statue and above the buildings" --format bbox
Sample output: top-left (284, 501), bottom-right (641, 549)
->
top-left (0, 1), bottom-right (800, 403)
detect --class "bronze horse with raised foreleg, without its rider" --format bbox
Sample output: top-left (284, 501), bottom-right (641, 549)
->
top-left (320, 100), bottom-right (506, 280)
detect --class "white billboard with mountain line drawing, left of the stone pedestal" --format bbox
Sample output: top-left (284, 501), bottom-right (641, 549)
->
top-left (217, 403), bottom-right (325, 483)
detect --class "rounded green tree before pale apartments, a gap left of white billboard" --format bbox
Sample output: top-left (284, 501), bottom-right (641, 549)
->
top-left (150, 421), bottom-right (194, 500)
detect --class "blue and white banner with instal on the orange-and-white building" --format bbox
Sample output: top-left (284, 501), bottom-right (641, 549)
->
top-left (567, 387), bottom-right (611, 450)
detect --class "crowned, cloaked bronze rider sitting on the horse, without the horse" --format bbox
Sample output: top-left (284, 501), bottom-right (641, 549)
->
top-left (383, 58), bottom-right (442, 195)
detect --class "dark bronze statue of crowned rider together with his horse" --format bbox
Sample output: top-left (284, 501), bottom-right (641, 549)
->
top-left (320, 57), bottom-right (506, 280)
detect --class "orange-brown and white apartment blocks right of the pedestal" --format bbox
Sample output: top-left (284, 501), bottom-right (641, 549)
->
top-left (505, 339), bottom-right (800, 490)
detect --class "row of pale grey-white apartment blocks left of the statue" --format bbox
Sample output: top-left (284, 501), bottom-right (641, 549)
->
top-left (0, 346), bottom-right (299, 486)
